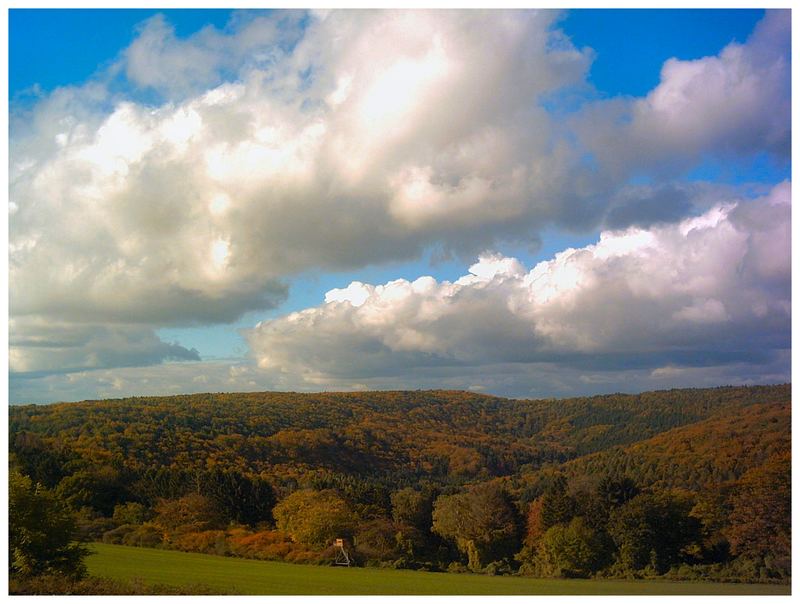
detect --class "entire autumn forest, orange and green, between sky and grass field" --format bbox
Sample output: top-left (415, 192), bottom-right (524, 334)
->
top-left (9, 384), bottom-right (791, 582)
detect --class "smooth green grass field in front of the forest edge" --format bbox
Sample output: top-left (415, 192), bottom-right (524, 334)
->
top-left (87, 543), bottom-right (790, 595)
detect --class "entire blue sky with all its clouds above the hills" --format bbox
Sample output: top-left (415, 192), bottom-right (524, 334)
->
top-left (8, 9), bottom-right (791, 404)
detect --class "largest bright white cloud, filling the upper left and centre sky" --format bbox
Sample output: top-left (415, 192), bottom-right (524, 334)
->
top-left (10, 11), bottom-right (600, 330)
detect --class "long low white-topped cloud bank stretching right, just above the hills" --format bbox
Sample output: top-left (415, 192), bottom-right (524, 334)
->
top-left (246, 183), bottom-right (791, 381)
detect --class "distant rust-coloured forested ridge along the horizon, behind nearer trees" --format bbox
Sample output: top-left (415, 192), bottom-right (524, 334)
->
top-left (10, 385), bottom-right (791, 485)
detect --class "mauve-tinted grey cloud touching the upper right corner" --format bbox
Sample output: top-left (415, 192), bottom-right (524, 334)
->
top-left (577, 10), bottom-right (791, 174)
